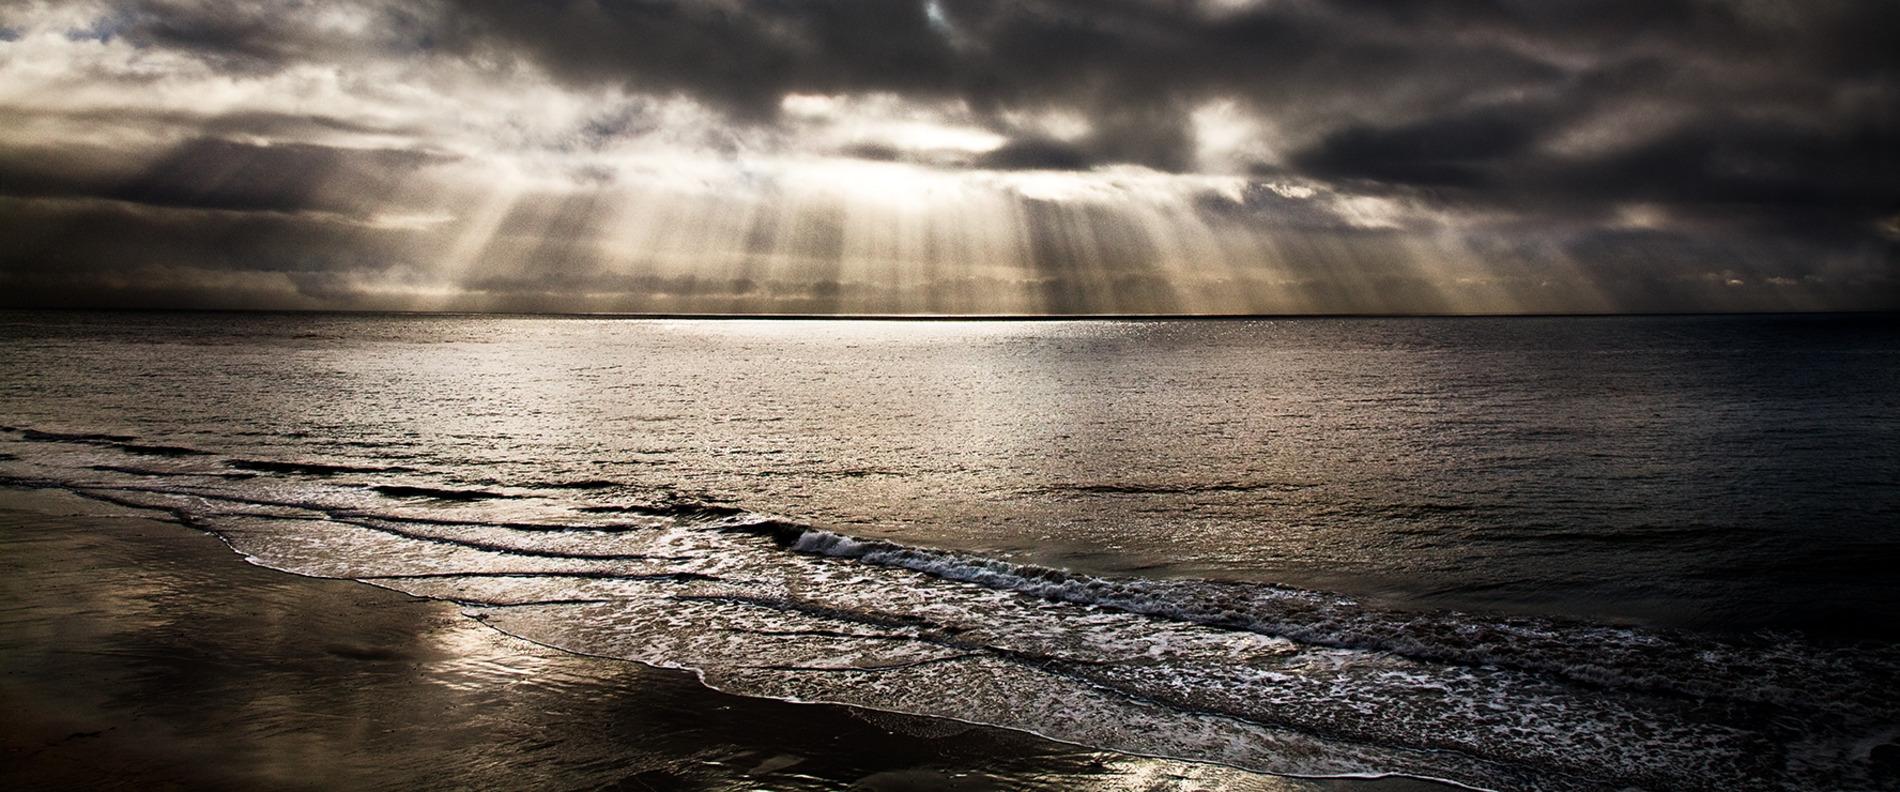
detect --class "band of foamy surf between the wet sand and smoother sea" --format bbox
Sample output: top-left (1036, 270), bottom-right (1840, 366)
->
top-left (0, 425), bottom-right (1900, 790)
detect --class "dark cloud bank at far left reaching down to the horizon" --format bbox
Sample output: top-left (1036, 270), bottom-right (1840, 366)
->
top-left (0, 131), bottom-right (452, 308)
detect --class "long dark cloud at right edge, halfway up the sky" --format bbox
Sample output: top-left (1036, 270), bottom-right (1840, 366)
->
top-left (1294, 101), bottom-right (1900, 232)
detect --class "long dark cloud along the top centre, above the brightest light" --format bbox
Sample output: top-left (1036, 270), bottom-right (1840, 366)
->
top-left (445, 0), bottom-right (1560, 169)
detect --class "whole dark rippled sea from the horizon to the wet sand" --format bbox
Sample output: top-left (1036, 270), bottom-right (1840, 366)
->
top-left (0, 313), bottom-right (1900, 788)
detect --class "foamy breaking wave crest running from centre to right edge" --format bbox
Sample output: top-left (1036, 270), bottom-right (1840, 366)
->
top-left (767, 520), bottom-right (1900, 712)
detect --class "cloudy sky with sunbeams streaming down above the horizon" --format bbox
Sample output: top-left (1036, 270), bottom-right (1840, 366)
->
top-left (0, 0), bottom-right (1900, 313)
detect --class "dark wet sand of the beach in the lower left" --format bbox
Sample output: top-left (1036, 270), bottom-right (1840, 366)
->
top-left (0, 490), bottom-right (1442, 792)
